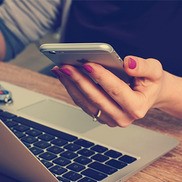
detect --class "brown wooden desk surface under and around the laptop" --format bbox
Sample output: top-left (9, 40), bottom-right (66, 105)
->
top-left (0, 63), bottom-right (182, 182)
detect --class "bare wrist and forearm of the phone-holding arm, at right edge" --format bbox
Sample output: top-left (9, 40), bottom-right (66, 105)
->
top-left (157, 72), bottom-right (182, 118)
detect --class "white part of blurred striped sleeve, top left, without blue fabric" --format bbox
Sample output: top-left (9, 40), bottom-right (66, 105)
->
top-left (0, 0), bottom-right (64, 45)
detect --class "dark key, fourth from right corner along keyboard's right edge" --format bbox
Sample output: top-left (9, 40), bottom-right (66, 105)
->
top-left (81, 168), bottom-right (107, 181)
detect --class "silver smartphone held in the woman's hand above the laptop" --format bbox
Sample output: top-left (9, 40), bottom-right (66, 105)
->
top-left (40, 43), bottom-right (131, 83)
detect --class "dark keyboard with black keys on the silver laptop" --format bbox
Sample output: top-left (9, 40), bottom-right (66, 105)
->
top-left (0, 110), bottom-right (137, 182)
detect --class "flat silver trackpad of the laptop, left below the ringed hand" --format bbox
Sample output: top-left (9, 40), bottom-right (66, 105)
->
top-left (19, 99), bottom-right (99, 133)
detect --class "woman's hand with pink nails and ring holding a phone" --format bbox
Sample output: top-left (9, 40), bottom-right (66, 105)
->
top-left (52, 56), bottom-right (164, 127)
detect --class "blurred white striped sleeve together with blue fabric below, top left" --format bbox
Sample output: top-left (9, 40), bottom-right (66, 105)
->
top-left (0, 0), bottom-right (63, 61)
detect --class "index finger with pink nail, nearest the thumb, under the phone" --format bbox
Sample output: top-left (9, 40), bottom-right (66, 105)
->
top-left (84, 63), bottom-right (137, 110)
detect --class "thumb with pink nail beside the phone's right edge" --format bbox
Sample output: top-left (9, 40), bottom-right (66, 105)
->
top-left (124, 56), bottom-right (163, 80)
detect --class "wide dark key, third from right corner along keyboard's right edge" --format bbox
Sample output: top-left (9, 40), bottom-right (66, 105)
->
top-left (88, 162), bottom-right (117, 175)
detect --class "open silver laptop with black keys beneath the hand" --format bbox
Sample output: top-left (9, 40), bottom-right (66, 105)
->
top-left (0, 82), bottom-right (179, 182)
